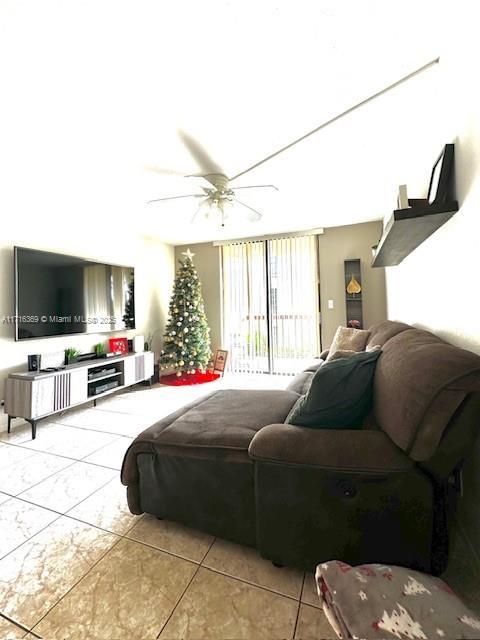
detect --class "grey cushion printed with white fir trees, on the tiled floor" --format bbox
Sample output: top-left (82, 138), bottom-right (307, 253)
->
top-left (315, 560), bottom-right (480, 640)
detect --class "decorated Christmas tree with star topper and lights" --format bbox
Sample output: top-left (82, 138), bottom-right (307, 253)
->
top-left (160, 249), bottom-right (212, 377)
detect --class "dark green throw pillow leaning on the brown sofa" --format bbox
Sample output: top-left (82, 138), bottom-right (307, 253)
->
top-left (285, 350), bottom-right (381, 429)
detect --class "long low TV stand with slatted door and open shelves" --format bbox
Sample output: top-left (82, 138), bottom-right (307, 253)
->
top-left (4, 351), bottom-right (154, 439)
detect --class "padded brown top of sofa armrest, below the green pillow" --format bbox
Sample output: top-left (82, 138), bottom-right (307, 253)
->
top-left (248, 424), bottom-right (414, 473)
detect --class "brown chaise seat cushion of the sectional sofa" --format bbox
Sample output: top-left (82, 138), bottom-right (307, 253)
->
top-left (122, 389), bottom-right (298, 484)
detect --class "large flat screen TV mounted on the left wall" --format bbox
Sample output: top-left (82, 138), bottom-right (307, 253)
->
top-left (14, 247), bottom-right (135, 340)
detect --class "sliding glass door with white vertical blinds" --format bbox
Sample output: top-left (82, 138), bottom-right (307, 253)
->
top-left (222, 236), bottom-right (319, 374)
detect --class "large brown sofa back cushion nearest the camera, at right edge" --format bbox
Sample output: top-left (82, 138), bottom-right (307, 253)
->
top-left (374, 328), bottom-right (480, 461)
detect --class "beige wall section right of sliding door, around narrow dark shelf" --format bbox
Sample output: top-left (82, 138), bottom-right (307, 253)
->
top-left (318, 222), bottom-right (387, 349)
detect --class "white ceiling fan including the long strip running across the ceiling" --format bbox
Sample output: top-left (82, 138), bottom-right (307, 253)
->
top-left (147, 58), bottom-right (439, 227)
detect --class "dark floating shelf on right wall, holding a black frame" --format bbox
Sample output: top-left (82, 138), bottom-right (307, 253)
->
top-left (372, 200), bottom-right (458, 267)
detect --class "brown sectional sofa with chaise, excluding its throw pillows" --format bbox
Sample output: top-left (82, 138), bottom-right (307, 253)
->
top-left (122, 321), bottom-right (480, 573)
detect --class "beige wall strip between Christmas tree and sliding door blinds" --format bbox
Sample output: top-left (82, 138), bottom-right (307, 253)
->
top-left (175, 242), bottom-right (222, 352)
